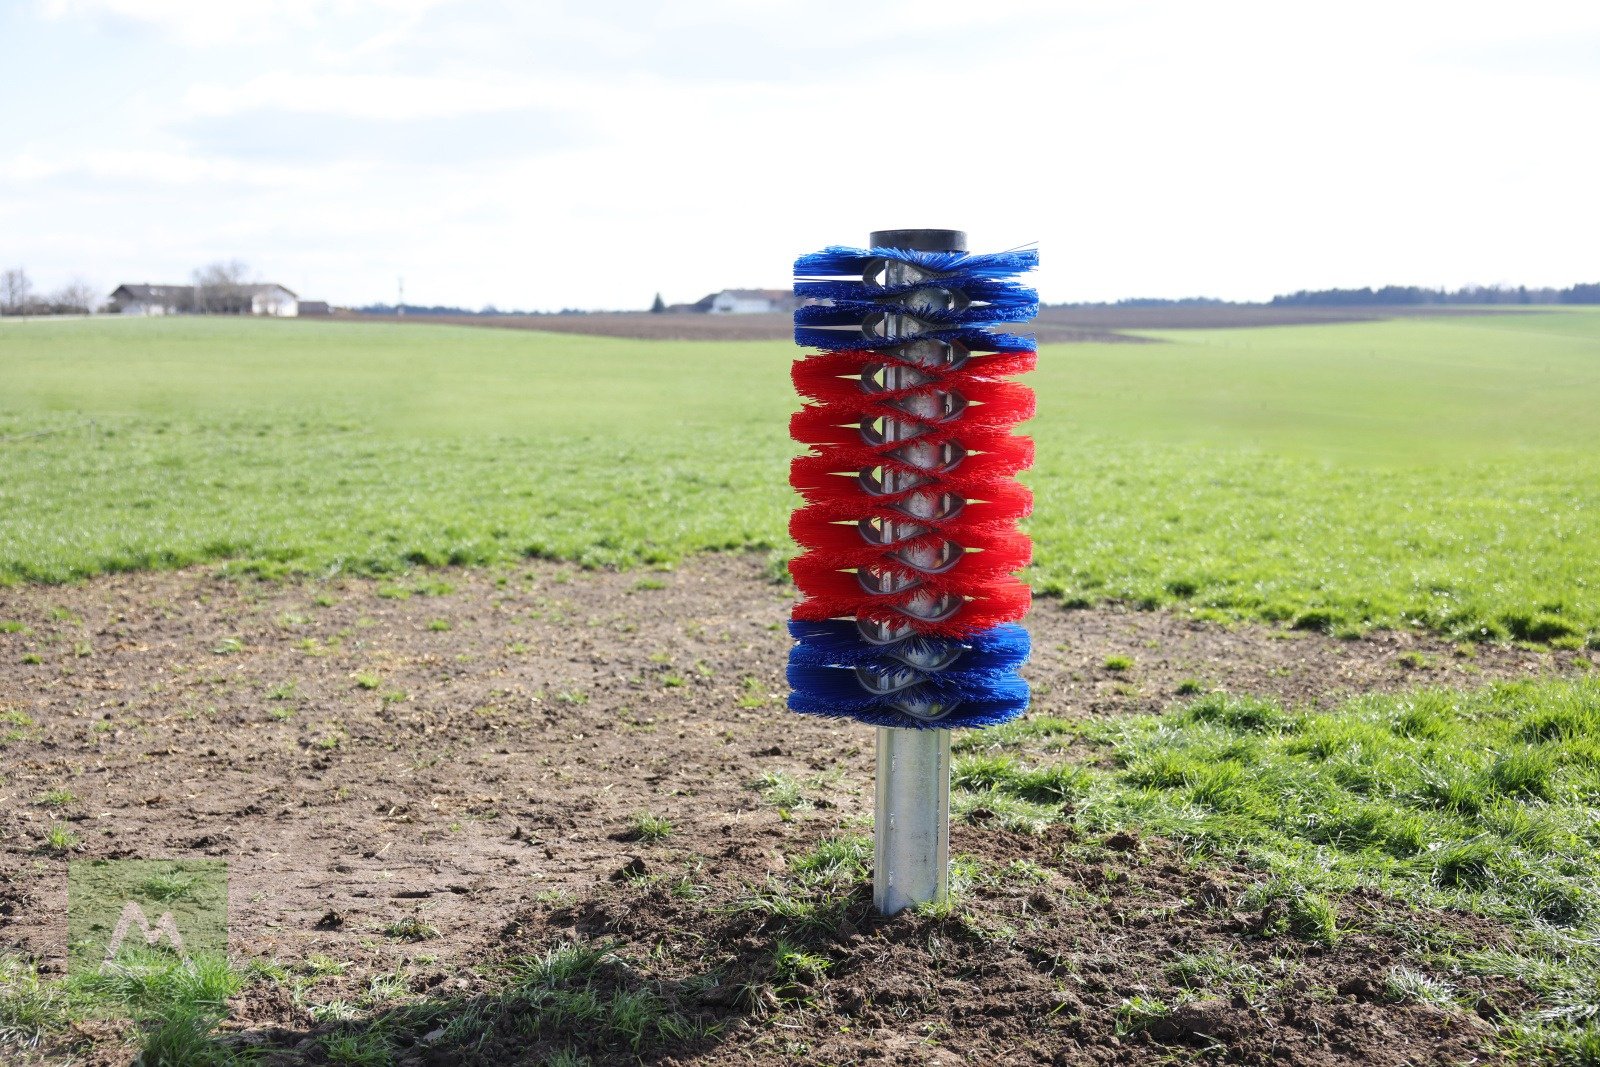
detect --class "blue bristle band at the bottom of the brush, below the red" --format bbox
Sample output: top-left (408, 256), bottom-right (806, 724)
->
top-left (789, 621), bottom-right (1029, 729)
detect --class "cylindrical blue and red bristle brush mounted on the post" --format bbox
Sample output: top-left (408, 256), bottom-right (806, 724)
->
top-left (789, 232), bottom-right (1038, 728)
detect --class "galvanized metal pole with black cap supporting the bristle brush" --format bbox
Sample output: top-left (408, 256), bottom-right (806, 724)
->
top-left (870, 230), bottom-right (966, 915)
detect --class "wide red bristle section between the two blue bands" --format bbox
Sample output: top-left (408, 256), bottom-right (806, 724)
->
top-left (789, 335), bottom-right (1038, 637)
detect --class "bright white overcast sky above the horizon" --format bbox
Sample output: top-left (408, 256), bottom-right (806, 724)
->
top-left (0, 0), bottom-right (1600, 309)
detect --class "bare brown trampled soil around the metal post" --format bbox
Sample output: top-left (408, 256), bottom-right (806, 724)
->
top-left (0, 555), bottom-right (1587, 1064)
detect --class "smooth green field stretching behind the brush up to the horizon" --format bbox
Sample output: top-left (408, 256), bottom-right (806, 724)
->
top-left (0, 310), bottom-right (1600, 646)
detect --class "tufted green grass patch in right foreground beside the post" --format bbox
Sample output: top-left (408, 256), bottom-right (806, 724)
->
top-left (954, 678), bottom-right (1600, 1067)
